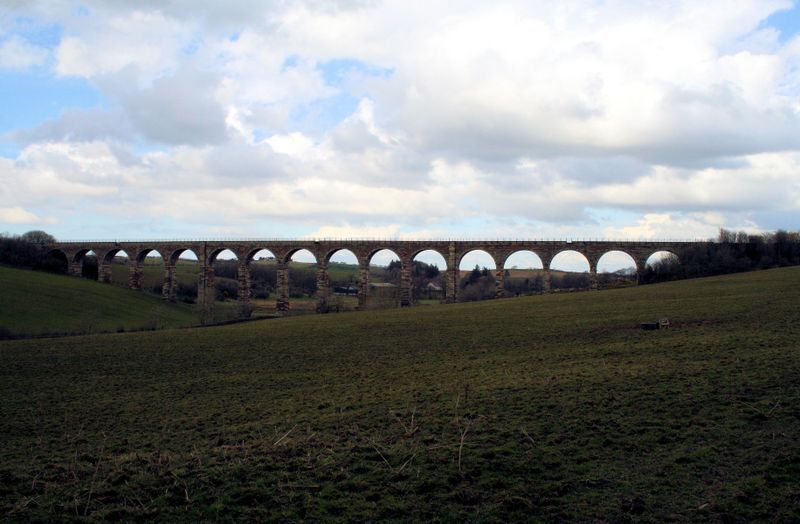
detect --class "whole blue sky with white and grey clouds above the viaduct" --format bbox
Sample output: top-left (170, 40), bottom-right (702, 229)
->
top-left (0, 0), bottom-right (800, 243)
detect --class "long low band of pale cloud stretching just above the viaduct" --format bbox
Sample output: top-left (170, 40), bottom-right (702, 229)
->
top-left (6, 135), bottom-right (800, 242)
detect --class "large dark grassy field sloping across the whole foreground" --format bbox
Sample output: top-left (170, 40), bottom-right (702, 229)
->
top-left (0, 268), bottom-right (800, 522)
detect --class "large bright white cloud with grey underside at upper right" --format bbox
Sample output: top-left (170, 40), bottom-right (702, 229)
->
top-left (379, 4), bottom-right (800, 163)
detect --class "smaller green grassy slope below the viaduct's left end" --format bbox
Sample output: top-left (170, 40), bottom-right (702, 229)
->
top-left (0, 267), bottom-right (198, 335)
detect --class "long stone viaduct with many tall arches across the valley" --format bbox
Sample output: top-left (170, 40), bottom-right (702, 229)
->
top-left (48, 240), bottom-right (702, 312)
